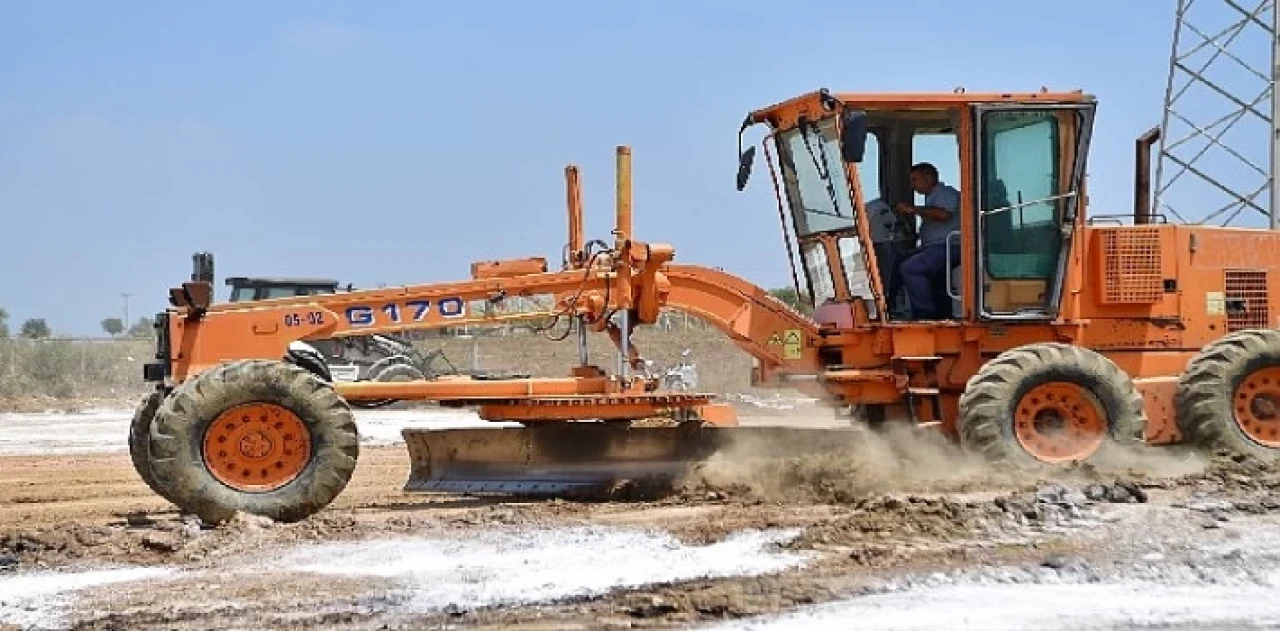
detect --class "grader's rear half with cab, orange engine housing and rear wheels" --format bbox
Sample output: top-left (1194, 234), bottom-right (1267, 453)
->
top-left (739, 86), bottom-right (1280, 466)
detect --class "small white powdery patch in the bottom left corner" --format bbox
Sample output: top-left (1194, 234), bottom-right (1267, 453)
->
top-left (0, 567), bottom-right (173, 628)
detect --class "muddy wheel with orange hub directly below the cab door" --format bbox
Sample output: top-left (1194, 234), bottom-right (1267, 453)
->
top-left (959, 343), bottom-right (1147, 468)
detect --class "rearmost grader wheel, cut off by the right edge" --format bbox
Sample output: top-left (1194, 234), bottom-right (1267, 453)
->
top-left (1174, 329), bottom-right (1280, 462)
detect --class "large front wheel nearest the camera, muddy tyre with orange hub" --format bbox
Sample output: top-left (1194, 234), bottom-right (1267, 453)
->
top-left (148, 360), bottom-right (360, 523)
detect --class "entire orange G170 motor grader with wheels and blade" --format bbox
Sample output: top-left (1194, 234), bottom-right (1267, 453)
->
top-left (129, 91), bottom-right (1280, 521)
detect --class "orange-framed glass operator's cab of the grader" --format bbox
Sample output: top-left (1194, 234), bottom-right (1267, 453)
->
top-left (740, 92), bottom-right (1094, 325)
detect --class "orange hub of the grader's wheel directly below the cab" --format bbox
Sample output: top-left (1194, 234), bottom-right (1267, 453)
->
top-left (1014, 381), bottom-right (1107, 462)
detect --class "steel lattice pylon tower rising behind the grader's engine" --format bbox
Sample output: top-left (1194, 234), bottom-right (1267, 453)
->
top-left (1153, 0), bottom-right (1280, 229)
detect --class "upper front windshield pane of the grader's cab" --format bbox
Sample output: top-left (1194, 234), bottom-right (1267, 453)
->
top-left (778, 118), bottom-right (854, 237)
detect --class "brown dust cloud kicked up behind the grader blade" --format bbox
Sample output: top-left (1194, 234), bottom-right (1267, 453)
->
top-left (681, 407), bottom-right (1207, 503)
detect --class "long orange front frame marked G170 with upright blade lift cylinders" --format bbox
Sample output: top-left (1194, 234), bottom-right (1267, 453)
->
top-left (152, 147), bottom-right (820, 420)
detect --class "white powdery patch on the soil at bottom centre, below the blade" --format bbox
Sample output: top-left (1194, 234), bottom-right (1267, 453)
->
top-left (273, 527), bottom-right (808, 611)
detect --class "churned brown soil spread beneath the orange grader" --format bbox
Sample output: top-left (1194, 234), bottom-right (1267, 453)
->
top-left (0, 424), bottom-right (1280, 628)
